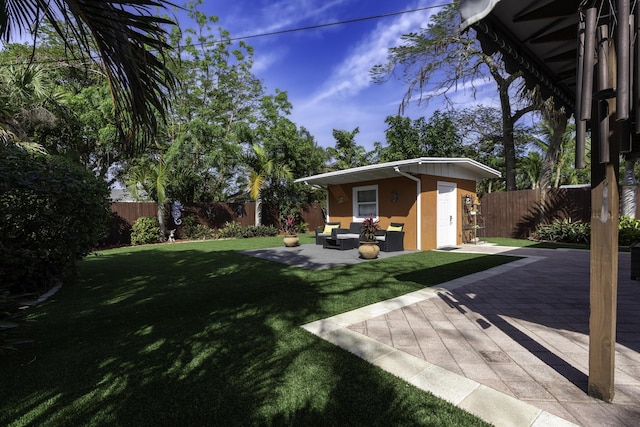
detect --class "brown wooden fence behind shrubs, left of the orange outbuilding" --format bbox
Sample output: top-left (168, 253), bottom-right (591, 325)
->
top-left (103, 202), bottom-right (324, 246)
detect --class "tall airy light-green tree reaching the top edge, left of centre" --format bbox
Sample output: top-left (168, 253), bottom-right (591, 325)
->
top-left (145, 1), bottom-right (265, 202)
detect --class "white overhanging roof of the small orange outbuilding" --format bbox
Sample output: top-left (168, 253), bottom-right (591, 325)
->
top-left (295, 157), bottom-right (501, 186)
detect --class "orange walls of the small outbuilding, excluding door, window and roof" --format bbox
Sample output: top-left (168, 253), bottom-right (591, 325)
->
top-left (327, 175), bottom-right (476, 250)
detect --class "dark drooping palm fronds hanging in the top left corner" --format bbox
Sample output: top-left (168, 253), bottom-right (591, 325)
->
top-left (0, 0), bottom-right (175, 152)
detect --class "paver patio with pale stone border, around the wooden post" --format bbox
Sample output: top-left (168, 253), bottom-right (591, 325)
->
top-left (296, 245), bottom-right (640, 426)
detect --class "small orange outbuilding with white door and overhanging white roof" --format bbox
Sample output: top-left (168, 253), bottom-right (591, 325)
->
top-left (295, 157), bottom-right (501, 251)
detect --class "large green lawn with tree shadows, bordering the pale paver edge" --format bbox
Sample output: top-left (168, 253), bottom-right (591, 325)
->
top-left (0, 236), bottom-right (513, 426)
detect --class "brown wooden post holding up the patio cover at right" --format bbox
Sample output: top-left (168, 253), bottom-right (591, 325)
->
top-left (588, 34), bottom-right (619, 402)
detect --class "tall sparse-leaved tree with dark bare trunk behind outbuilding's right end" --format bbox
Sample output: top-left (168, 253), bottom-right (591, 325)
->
top-left (371, 1), bottom-right (534, 190)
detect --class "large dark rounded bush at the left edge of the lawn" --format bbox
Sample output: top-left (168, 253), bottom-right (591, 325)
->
top-left (0, 143), bottom-right (110, 294)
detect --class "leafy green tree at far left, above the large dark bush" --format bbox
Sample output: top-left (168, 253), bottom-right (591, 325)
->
top-left (0, 30), bottom-right (124, 180)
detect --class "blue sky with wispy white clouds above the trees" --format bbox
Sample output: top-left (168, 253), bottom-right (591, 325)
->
top-left (181, 0), bottom-right (495, 150)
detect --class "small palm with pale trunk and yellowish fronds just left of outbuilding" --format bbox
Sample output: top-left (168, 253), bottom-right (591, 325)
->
top-left (245, 144), bottom-right (293, 225)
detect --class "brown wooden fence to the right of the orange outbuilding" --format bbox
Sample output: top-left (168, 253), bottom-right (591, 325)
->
top-left (480, 187), bottom-right (640, 238)
